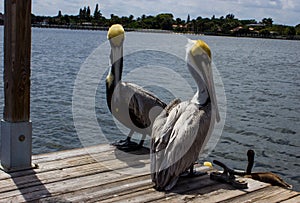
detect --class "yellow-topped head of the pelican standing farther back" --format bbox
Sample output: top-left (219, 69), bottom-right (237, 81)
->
top-left (107, 24), bottom-right (125, 46)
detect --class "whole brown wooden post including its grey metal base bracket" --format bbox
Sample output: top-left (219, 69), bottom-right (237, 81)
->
top-left (0, 0), bottom-right (33, 172)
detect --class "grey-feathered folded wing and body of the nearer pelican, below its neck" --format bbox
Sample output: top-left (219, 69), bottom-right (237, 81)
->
top-left (151, 102), bottom-right (210, 189)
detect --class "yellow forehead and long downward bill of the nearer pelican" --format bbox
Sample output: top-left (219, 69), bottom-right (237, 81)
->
top-left (190, 40), bottom-right (220, 122)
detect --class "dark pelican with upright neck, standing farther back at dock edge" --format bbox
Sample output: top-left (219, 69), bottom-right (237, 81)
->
top-left (106, 24), bottom-right (166, 151)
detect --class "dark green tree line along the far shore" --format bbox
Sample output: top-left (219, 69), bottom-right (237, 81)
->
top-left (10, 4), bottom-right (300, 37)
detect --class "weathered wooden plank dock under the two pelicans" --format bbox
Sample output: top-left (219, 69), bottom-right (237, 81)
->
top-left (0, 145), bottom-right (300, 203)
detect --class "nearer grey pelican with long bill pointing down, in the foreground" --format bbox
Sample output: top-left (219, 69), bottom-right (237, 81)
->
top-left (150, 40), bottom-right (220, 190)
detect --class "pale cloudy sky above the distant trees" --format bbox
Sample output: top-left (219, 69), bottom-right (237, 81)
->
top-left (0, 0), bottom-right (300, 26)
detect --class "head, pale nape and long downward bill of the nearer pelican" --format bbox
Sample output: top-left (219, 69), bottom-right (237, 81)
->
top-left (186, 40), bottom-right (220, 122)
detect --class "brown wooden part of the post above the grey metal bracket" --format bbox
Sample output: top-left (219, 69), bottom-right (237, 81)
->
top-left (3, 0), bottom-right (31, 122)
